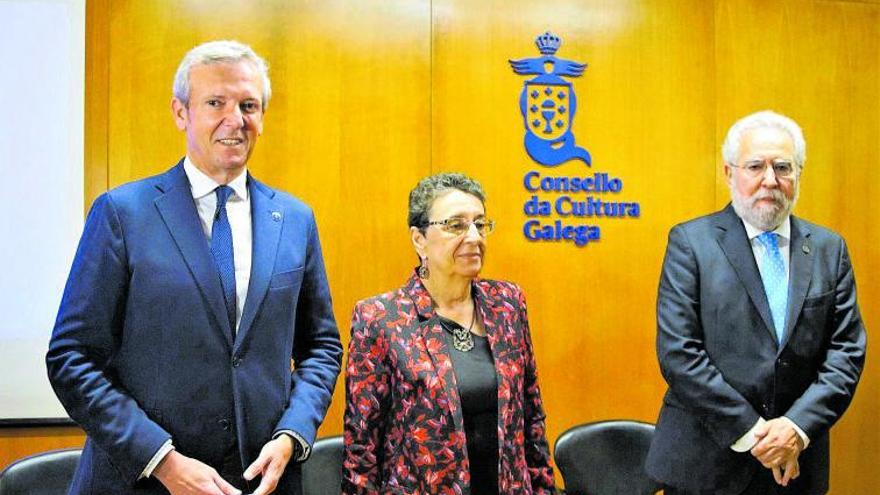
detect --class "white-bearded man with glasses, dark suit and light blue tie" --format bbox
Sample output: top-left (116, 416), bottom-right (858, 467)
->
top-left (646, 111), bottom-right (866, 495)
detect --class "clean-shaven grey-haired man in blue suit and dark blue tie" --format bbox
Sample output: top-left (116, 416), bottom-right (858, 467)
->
top-left (46, 41), bottom-right (342, 495)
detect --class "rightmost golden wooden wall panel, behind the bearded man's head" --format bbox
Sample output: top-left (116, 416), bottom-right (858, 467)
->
top-left (716, 0), bottom-right (880, 494)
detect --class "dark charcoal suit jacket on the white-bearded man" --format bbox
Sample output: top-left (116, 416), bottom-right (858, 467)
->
top-left (646, 206), bottom-right (866, 495)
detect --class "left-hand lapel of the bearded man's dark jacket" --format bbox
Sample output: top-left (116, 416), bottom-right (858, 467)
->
top-left (716, 205), bottom-right (777, 343)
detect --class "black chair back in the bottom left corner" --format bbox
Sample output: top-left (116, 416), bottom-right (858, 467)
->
top-left (0, 449), bottom-right (82, 495)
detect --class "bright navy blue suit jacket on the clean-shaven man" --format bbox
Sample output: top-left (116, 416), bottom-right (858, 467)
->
top-left (46, 162), bottom-right (342, 494)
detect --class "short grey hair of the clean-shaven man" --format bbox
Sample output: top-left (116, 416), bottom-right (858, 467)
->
top-left (174, 40), bottom-right (272, 111)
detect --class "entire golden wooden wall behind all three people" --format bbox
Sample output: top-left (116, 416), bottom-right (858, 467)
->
top-left (0, 0), bottom-right (880, 493)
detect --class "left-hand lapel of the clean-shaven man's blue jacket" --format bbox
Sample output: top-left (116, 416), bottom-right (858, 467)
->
top-left (154, 160), bottom-right (232, 347)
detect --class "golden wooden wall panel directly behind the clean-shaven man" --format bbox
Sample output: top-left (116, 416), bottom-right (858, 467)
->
top-left (101, 0), bottom-right (430, 434)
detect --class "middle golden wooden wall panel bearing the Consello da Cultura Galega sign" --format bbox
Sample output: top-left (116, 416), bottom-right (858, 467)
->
top-left (433, 0), bottom-right (715, 464)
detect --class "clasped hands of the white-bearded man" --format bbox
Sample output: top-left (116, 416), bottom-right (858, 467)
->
top-left (751, 418), bottom-right (804, 486)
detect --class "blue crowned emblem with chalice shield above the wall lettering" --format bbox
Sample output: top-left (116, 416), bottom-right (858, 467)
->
top-left (510, 31), bottom-right (590, 167)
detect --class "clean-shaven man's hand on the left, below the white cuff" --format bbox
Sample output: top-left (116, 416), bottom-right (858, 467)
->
top-left (153, 450), bottom-right (241, 495)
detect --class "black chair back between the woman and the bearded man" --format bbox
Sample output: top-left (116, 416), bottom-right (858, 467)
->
top-left (553, 420), bottom-right (662, 495)
